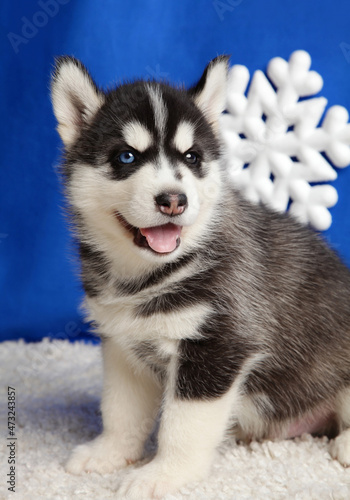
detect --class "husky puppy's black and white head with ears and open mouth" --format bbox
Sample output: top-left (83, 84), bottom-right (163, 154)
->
top-left (52, 56), bottom-right (228, 262)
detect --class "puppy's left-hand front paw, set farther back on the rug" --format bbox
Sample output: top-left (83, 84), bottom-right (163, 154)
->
top-left (65, 435), bottom-right (140, 474)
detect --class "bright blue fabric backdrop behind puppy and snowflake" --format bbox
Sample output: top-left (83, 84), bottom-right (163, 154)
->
top-left (0, 0), bottom-right (350, 340)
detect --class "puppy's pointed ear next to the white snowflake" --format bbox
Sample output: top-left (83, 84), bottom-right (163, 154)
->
top-left (189, 56), bottom-right (230, 129)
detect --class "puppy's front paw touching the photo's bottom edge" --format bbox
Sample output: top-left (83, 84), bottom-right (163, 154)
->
top-left (117, 460), bottom-right (205, 500)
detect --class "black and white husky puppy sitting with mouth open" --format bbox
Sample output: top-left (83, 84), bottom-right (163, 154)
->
top-left (52, 56), bottom-right (350, 500)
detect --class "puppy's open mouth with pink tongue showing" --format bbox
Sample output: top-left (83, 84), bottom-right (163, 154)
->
top-left (114, 212), bottom-right (182, 255)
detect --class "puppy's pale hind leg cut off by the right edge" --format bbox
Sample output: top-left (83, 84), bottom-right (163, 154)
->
top-left (330, 387), bottom-right (350, 467)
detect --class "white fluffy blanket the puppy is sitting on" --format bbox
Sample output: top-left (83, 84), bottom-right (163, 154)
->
top-left (0, 339), bottom-right (350, 500)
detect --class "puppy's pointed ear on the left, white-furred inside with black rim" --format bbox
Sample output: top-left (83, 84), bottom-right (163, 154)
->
top-left (51, 56), bottom-right (104, 146)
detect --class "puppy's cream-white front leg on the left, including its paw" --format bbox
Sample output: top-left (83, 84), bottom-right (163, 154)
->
top-left (66, 339), bottom-right (161, 474)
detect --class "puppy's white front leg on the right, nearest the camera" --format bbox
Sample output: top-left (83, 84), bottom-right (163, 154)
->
top-left (117, 346), bottom-right (233, 500)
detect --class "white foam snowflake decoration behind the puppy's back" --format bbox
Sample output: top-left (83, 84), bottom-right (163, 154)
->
top-left (221, 50), bottom-right (350, 231)
